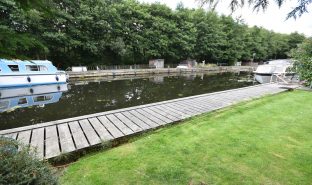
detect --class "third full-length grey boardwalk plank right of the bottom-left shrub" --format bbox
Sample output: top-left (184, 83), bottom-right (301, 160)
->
top-left (68, 121), bottom-right (89, 149)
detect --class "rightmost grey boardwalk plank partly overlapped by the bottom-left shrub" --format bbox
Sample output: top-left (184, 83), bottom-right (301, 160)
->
top-left (30, 128), bottom-right (44, 159)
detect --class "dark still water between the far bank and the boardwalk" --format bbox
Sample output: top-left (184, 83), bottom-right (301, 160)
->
top-left (0, 73), bottom-right (252, 130)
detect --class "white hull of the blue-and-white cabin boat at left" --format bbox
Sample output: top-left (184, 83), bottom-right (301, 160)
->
top-left (0, 73), bottom-right (67, 88)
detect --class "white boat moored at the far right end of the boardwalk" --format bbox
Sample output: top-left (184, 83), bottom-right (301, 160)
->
top-left (253, 59), bottom-right (298, 84)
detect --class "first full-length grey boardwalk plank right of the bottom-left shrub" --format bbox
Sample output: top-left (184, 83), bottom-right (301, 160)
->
top-left (45, 125), bottom-right (61, 159)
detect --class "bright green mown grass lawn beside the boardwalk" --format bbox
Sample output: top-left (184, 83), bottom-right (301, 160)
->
top-left (61, 91), bottom-right (312, 185)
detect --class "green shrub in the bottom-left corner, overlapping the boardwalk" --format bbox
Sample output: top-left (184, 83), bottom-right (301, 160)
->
top-left (0, 136), bottom-right (58, 185)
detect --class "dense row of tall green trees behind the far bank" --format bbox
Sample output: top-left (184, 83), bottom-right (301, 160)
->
top-left (0, 0), bottom-right (304, 68)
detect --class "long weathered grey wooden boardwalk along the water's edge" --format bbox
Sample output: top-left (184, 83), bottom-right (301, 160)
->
top-left (0, 84), bottom-right (286, 159)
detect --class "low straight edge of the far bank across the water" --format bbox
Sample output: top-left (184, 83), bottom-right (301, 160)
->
top-left (66, 66), bottom-right (255, 79)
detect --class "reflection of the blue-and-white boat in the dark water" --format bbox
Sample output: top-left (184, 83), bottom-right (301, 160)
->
top-left (0, 84), bottom-right (68, 113)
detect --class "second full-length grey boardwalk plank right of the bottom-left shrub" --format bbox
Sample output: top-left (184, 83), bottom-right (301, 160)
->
top-left (57, 123), bottom-right (76, 153)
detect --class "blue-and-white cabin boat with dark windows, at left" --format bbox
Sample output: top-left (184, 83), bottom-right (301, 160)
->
top-left (0, 59), bottom-right (67, 88)
